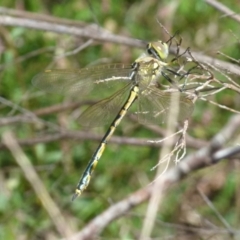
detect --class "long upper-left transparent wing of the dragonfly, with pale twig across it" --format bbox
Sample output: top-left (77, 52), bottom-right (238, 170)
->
top-left (32, 64), bottom-right (132, 98)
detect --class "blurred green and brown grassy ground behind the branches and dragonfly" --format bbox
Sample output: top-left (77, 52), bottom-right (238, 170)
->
top-left (0, 0), bottom-right (240, 240)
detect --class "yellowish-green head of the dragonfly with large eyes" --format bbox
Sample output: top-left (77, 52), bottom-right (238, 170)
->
top-left (147, 41), bottom-right (169, 60)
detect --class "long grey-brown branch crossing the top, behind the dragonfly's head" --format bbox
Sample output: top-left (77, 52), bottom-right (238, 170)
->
top-left (0, 8), bottom-right (240, 75)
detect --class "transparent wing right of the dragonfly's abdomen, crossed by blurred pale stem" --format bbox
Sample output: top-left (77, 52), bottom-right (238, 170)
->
top-left (137, 87), bottom-right (193, 125)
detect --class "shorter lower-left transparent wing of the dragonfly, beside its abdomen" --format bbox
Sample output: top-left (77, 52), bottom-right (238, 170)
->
top-left (79, 83), bottom-right (131, 127)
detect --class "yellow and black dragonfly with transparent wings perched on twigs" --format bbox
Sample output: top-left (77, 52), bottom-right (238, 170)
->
top-left (32, 41), bottom-right (193, 200)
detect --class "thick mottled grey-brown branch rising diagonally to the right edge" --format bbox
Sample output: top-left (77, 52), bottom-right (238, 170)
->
top-left (66, 115), bottom-right (240, 240)
